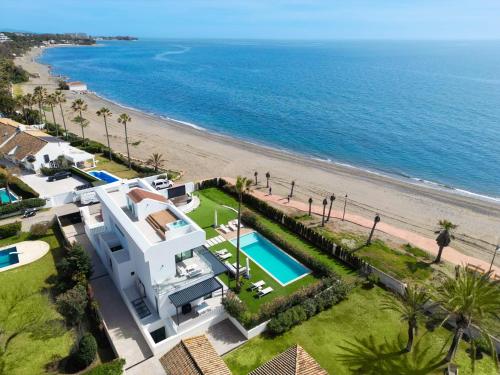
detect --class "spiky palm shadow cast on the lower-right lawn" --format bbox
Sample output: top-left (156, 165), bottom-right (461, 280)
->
top-left (337, 335), bottom-right (445, 375)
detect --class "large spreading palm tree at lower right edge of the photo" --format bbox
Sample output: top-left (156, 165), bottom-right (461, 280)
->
top-left (433, 267), bottom-right (500, 366)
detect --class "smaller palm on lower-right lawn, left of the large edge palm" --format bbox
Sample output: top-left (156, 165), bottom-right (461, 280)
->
top-left (382, 285), bottom-right (429, 352)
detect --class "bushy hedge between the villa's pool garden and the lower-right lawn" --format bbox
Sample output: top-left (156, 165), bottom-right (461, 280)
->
top-left (267, 283), bottom-right (350, 335)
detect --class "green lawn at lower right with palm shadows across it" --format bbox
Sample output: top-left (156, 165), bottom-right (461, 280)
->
top-left (224, 287), bottom-right (497, 375)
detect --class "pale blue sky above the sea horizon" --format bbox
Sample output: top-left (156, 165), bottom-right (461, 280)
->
top-left (0, 0), bottom-right (500, 39)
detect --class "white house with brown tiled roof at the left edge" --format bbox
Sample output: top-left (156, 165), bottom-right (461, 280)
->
top-left (0, 118), bottom-right (95, 172)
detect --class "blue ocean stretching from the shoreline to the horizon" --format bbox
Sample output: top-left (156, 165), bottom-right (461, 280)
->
top-left (40, 39), bottom-right (500, 198)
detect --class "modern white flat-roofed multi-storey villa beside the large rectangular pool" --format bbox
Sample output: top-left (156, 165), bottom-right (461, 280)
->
top-left (80, 178), bottom-right (226, 351)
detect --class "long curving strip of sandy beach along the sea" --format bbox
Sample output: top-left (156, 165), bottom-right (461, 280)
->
top-left (16, 47), bottom-right (500, 265)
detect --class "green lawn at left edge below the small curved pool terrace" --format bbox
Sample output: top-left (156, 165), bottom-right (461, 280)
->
top-left (0, 231), bottom-right (74, 375)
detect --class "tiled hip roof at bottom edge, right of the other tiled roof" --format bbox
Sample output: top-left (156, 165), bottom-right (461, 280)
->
top-left (248, 345), bottom-right (328, 375)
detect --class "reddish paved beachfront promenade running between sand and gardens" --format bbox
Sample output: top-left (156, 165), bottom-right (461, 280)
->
top-left (224, 177), bottom-right (500, 276)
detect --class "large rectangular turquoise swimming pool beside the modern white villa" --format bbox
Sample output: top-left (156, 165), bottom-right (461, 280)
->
top-left (231, 232), bottom-right (311, 285)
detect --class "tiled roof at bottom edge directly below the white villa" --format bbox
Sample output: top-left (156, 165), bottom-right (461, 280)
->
top-left (160, 335), bottom-right (231, 375)
